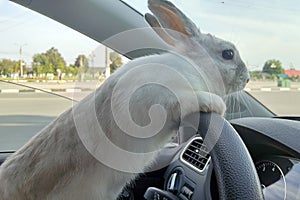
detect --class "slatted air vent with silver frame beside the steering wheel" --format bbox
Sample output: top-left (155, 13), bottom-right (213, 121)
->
top-left (180, 137), bottom-right (210, 172)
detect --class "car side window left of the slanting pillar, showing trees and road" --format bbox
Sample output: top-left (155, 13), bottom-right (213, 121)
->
top-left (0, 1), bottom-right (127, 151)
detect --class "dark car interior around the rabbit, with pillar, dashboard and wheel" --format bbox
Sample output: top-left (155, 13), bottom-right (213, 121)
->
top-left (0, 0), bottom-right (300, 200)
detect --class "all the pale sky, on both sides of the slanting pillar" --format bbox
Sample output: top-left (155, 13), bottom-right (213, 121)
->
top-left (0, 0), bottom-right (300, 70)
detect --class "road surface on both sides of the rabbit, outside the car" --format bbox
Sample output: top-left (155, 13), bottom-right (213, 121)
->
top-left (0, 90), bottom-right (300, 151)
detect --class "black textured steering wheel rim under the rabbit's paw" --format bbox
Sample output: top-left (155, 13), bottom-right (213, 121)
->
top-left (186, 112), bottom-right (264, 200)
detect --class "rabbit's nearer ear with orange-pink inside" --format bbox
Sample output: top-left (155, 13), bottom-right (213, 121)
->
top-left (148, 0), bottom-right (200, 39)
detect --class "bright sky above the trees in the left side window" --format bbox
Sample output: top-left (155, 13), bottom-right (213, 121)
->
top-left (0, 0), bottom-right (104, 66)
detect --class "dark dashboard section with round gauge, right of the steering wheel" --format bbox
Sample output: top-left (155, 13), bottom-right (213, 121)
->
top-left (231, 117), bottom-right (300, 200)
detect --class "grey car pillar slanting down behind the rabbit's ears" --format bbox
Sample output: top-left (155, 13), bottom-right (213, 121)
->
top-left (10, 0), bottom-right (167, 59)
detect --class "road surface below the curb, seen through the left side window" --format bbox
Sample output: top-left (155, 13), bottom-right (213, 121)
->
top-left (0, 93), bottom-right (73, 151)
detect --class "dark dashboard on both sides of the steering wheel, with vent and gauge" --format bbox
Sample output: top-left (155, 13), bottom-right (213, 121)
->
top-left (145, 117), bottom-right (300, 200)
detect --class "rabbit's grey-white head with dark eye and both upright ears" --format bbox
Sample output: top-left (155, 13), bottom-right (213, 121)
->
top-left (145, 0), bottom-right (249, 96)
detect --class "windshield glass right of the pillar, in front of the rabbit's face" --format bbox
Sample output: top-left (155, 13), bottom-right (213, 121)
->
top-left (124, 0), bottom-right (300, 115)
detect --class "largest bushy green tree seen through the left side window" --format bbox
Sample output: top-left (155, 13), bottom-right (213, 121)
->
top-left (32, 47), bottom-right (66, 74)
